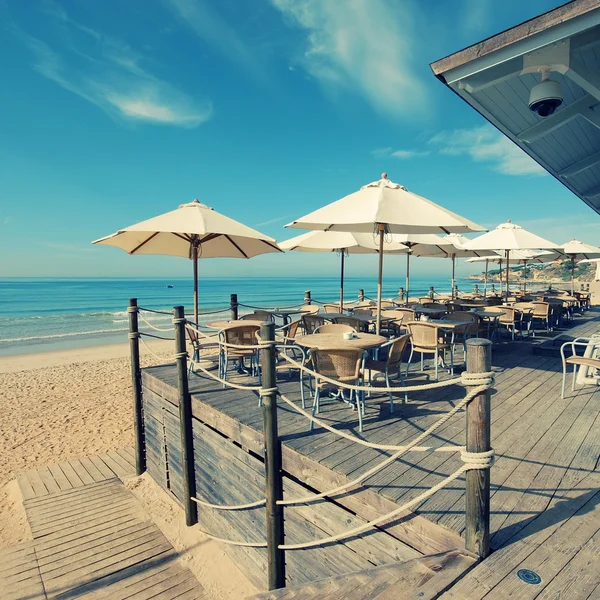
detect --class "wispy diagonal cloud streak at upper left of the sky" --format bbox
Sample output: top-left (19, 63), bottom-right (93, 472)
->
top-left (13, 3), bottom-right (212, 127)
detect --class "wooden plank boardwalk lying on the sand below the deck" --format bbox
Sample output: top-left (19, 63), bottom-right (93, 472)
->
top-left (0, 448), bottom-right (206, 600)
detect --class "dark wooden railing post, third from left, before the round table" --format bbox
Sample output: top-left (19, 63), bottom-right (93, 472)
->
top-left (260, 323), bottom-right (285, 590)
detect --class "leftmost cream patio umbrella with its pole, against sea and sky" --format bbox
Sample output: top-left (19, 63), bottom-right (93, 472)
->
top-left (92, 200), bottom-right (281, 323)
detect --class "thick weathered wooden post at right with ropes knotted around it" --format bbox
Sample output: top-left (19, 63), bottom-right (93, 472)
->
top-left (465, 338), bottom-right (492, 559)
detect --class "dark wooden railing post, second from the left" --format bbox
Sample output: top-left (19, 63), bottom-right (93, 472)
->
top-left (173, 306), bottom-right (198, 527)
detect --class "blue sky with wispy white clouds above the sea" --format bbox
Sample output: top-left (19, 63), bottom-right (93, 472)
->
top-left (0, 0), bottom-right (599, 277)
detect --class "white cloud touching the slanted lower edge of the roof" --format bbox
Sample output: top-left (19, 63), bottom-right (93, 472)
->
top-left (429, 125), bottom-right (547, 175)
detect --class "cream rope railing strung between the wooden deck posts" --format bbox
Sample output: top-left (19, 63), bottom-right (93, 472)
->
top-left (128, 296), bottom-right (494, 569)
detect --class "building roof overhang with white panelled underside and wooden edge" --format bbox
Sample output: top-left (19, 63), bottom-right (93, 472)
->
top-left (431, 0), bottom-right (600, 214)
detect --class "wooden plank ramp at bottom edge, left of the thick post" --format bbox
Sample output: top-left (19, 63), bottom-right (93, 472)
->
top-left (254, 550), bottom-right (476, 600)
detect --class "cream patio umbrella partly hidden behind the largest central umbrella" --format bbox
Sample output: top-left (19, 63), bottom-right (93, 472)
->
top-left (279, 231), bottom-right (408, 312)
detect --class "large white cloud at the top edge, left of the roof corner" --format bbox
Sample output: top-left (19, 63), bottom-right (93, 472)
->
top-left (271, 0), bottom-right (426, 116)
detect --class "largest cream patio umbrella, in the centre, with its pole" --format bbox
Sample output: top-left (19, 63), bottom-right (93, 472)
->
top-left (287, 173), bottom-right (485, 332)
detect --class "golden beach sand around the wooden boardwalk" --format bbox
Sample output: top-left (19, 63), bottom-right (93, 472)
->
top-left (0, 341), bottom-right (258, 600)
